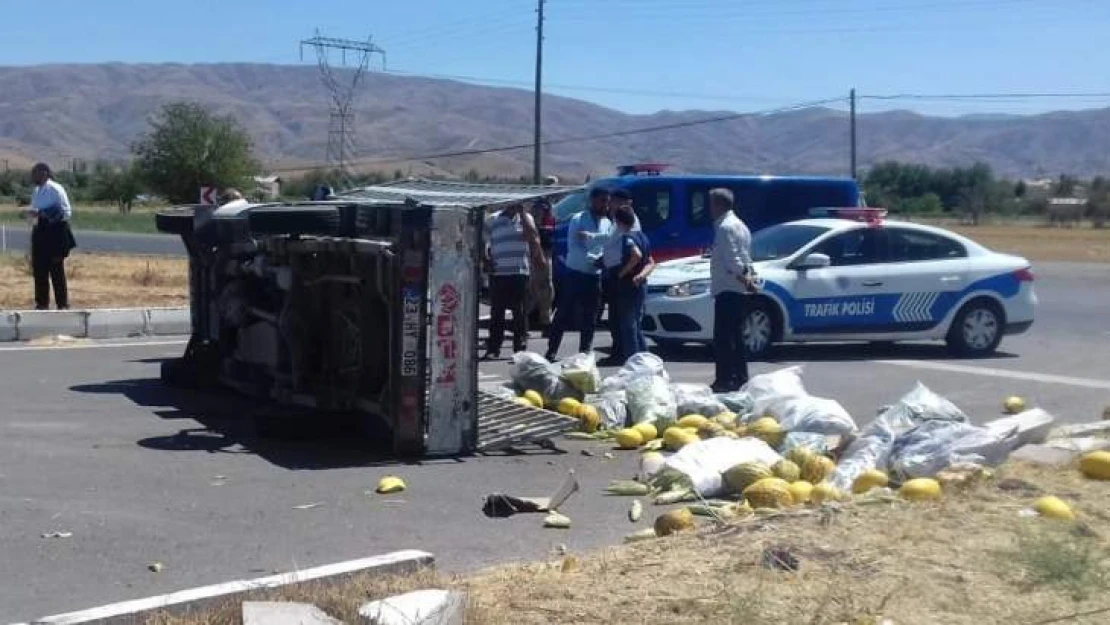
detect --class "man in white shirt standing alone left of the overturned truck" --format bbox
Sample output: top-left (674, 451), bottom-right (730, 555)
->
top-left (24, 163), bottom-right (77, 311)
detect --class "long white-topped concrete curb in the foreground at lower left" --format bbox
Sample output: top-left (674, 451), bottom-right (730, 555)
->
top-left (22, 550), bottom-right (435, 625)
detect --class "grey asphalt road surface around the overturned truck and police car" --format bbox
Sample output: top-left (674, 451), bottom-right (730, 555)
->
top-left (0, 260), bottom-right (1110, 622)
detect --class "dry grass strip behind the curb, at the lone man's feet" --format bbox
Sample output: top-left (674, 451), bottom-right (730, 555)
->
top-left (0, 249), bottom-right (189, 310)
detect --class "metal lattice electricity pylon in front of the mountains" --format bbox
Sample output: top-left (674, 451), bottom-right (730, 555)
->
top-left (301, 30), bottom-right (385, 187)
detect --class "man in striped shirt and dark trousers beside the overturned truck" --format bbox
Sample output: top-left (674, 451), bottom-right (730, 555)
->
top-left (485, 204), bottom-right (547, 360)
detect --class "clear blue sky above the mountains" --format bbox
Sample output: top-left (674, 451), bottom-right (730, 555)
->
top-left (0, 0), bottom-right (1110, 114)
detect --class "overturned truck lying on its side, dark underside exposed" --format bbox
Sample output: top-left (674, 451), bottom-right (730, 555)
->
top-left (155, 180), bottom-right (573, 455)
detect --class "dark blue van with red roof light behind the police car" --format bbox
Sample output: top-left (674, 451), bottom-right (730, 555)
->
top-left (552, 163), bottom-right (864, 275)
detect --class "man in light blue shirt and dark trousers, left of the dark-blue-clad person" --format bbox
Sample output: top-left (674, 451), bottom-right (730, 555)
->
top-left (547, 187), bottom-right (613, 361)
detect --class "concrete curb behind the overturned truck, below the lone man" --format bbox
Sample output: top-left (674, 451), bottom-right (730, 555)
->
top-left (0, 308), bottom-right (192, 342)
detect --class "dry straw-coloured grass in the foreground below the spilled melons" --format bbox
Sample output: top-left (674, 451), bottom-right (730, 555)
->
top-left (149, 465), bottom-right (1110, 625)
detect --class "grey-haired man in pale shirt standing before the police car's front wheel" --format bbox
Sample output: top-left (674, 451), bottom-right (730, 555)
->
top-left (709, 189), bottom-right (754, 393)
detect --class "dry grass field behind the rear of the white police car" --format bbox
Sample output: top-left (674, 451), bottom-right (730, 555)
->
top-left (910, 222), bottom-right (1110, 263)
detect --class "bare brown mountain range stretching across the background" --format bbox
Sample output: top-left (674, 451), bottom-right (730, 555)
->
top-left (0, 63), bottom-right (1110, 179)
